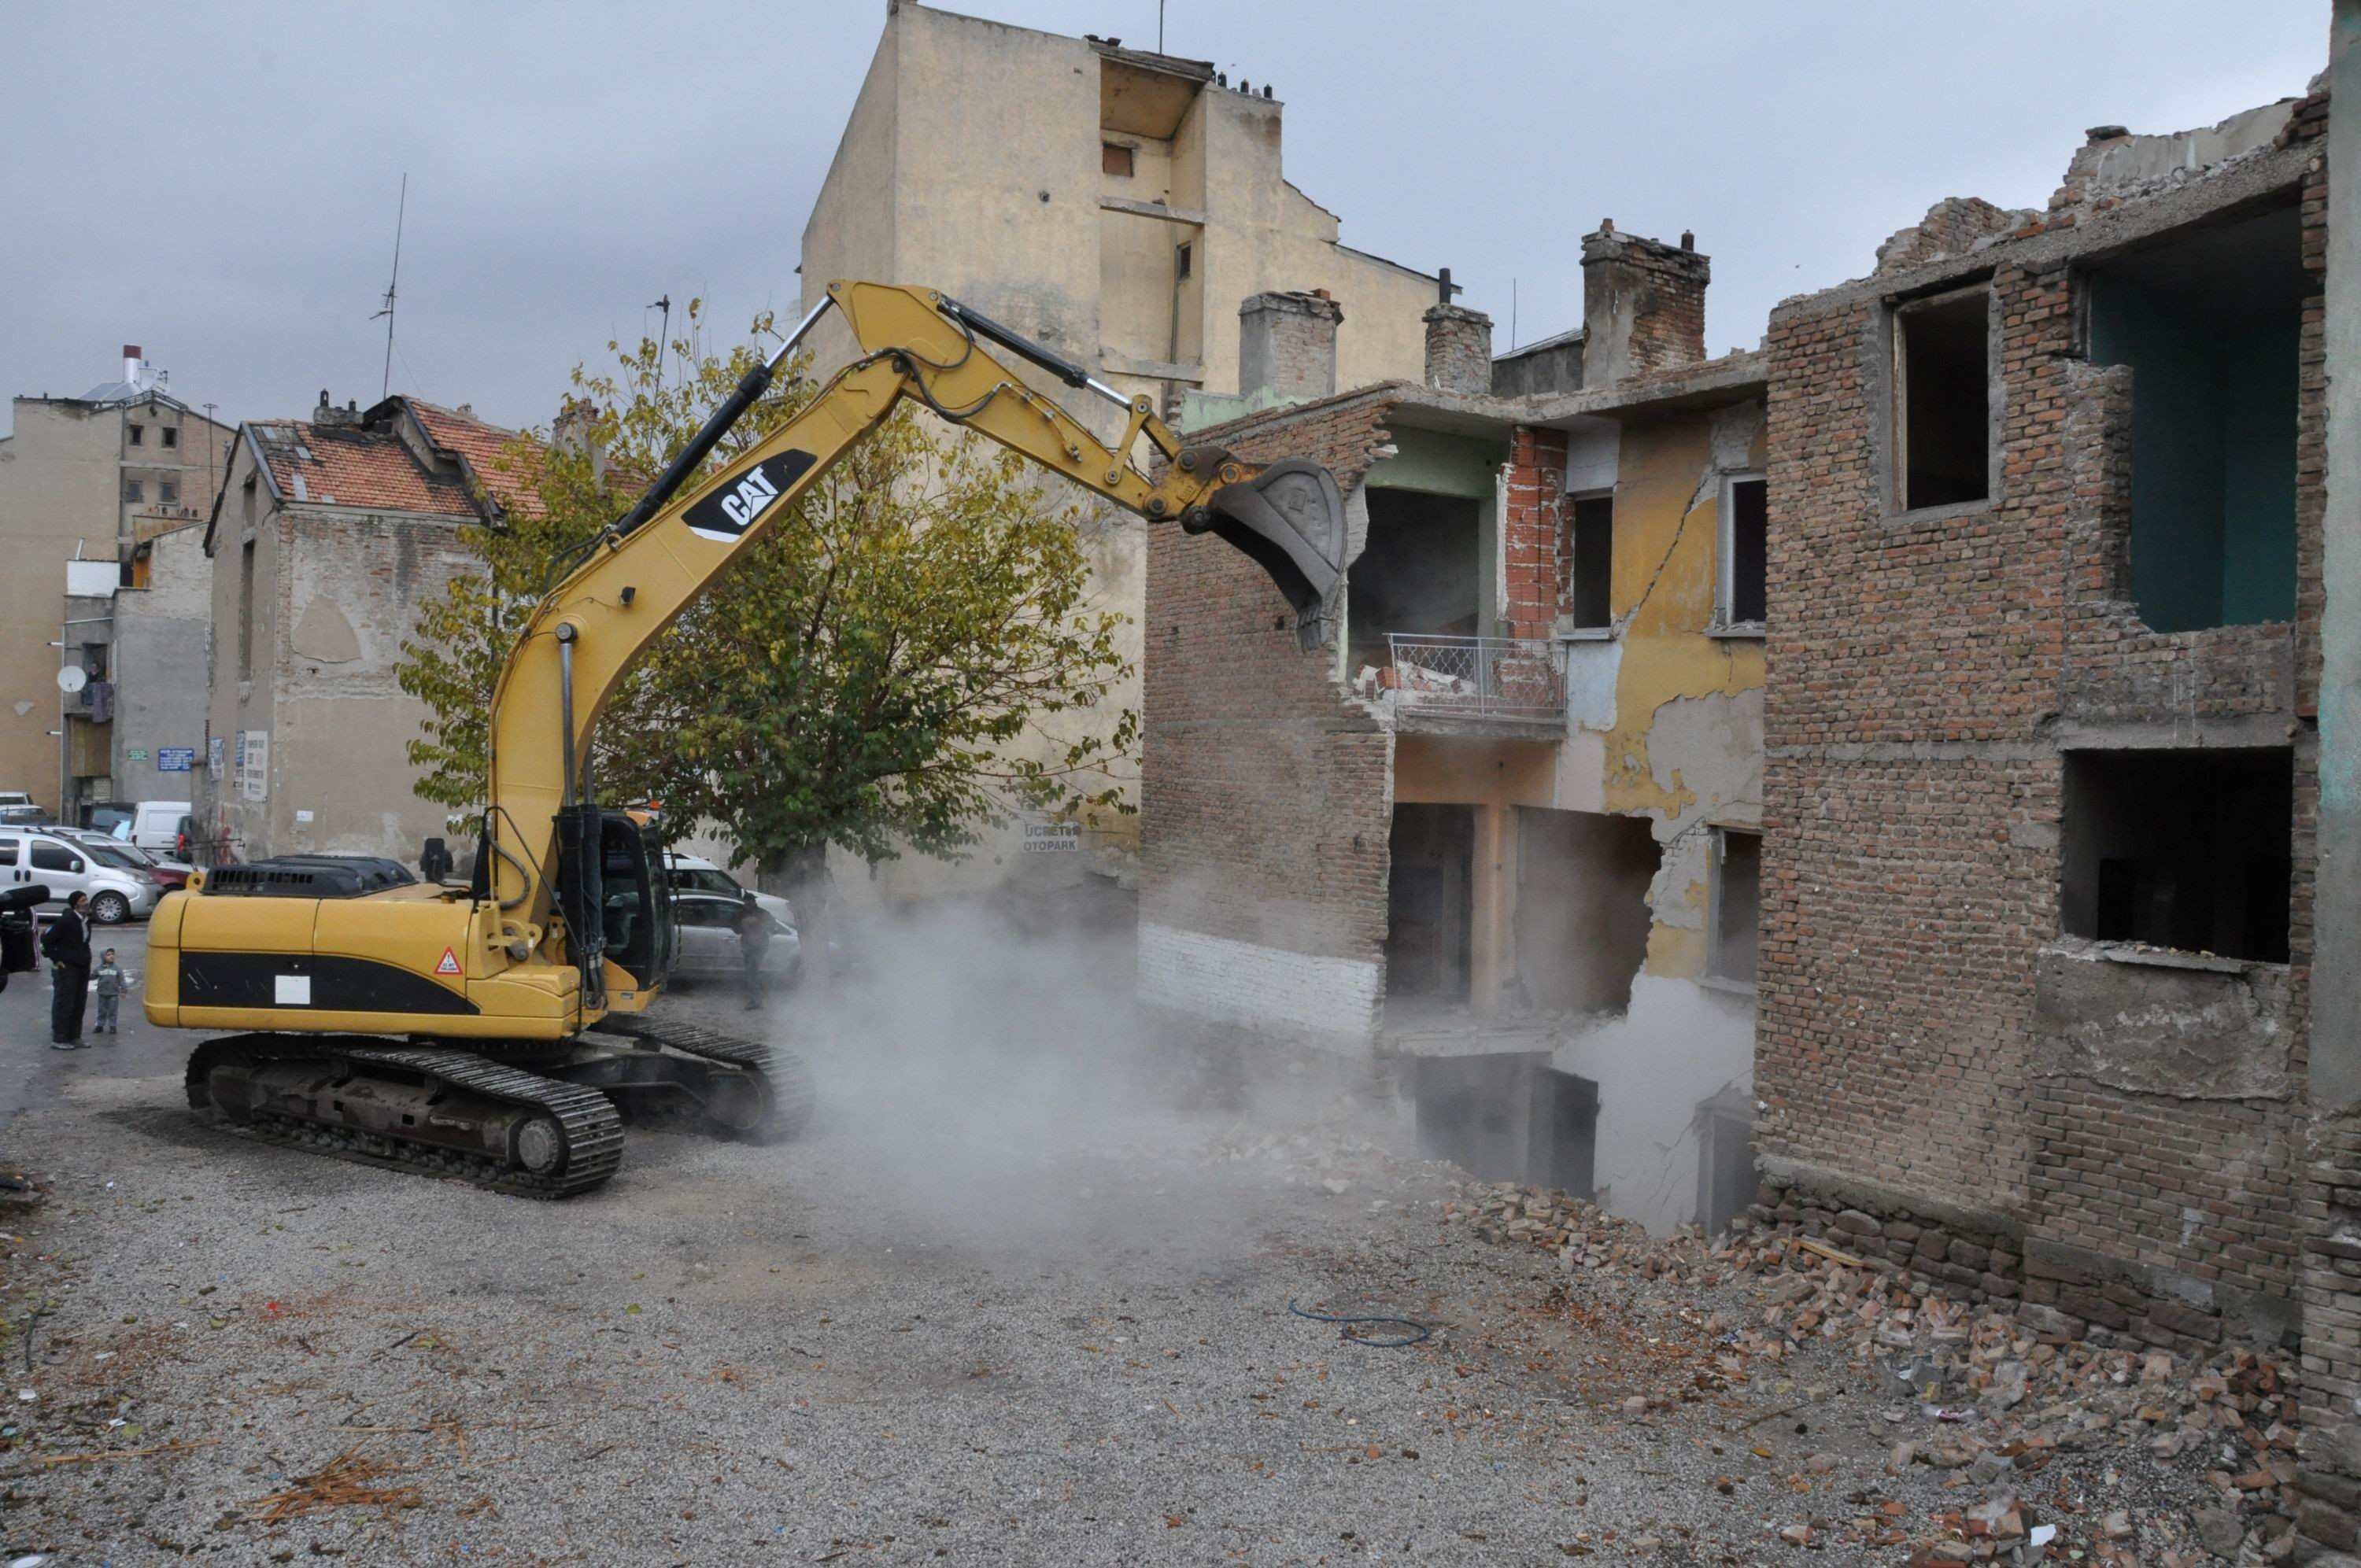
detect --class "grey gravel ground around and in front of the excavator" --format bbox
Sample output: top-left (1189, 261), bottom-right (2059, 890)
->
top-left (0, 925), bottom-right (2276, 1566)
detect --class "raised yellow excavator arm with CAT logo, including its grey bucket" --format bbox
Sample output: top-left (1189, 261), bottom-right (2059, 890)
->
top-left (477, 281), bottom-right (1343, 972)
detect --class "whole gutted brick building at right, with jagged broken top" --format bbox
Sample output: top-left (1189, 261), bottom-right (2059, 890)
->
top-left (1757, 101), bottom-right (2326, 1344)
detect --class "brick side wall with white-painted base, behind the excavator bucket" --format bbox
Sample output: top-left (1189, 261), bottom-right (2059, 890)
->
top-left (1140, 392), bottom-right (1393, 1042)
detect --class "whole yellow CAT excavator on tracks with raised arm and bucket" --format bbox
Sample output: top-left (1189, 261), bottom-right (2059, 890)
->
top-left (146, 281), bottom-right (1343, 1197)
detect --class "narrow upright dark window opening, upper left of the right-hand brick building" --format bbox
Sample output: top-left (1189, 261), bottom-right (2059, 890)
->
top-left (1894, 288), bottom-right (1993, 512)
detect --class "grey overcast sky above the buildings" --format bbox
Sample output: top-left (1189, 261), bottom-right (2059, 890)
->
top-left (0, 0), bottom-right (2328, 437)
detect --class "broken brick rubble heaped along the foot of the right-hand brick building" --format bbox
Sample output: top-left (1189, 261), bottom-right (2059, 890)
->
top-left (1443, 1183), bottom-right (2297, 1568)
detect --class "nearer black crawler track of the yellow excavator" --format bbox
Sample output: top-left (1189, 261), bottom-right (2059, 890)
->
top-left (187, 1035), bottom-right (623, 1197)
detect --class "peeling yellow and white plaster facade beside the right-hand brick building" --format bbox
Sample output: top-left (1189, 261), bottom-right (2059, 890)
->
top-left (1379, 397), bottom-right (1766, 1228)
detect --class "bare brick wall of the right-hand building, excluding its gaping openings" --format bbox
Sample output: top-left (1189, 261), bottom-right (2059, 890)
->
top-left (1757, 128), bottom-right (2314, 1346)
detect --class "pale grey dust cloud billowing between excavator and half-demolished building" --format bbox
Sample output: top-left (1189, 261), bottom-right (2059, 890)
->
top-left (751, 887), bottom-right (1391, 1256)
